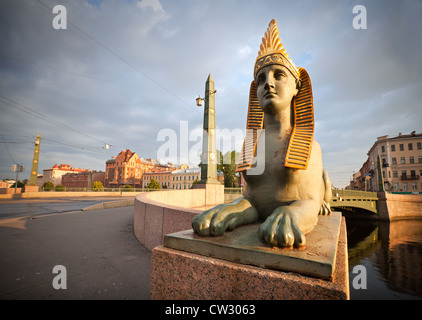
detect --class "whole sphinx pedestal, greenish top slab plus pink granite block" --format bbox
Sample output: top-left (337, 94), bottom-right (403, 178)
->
top-left (151, 213), bottom-right (349, 300)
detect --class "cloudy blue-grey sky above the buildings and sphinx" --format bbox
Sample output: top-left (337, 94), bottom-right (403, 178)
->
top-left (0, 0), bottom-right (422, 188)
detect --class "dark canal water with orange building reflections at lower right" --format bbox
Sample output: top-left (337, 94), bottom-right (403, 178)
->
top-left (346, 217), bottom-right (422, 300)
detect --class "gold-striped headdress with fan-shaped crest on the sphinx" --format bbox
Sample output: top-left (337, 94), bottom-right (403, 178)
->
top-left (236, 19), bottom-right (314, 172)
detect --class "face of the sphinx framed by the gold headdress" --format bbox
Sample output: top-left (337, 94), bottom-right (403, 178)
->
top-left (255, 64), bottom-right (298, 115)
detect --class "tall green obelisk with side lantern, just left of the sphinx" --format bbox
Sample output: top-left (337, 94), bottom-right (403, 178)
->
top-left (196, 74), bottom-right (219, 184)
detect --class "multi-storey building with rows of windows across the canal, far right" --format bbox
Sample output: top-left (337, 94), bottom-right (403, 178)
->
top-left (354, 131), bottom-right (422, 193)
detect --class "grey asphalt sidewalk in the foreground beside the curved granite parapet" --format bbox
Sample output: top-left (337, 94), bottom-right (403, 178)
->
top-left (0, 207), bottom-right (151, 300)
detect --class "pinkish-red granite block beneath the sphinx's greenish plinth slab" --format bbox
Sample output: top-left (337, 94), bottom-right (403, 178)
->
top-left (151, 219), bottom-right (349, 300)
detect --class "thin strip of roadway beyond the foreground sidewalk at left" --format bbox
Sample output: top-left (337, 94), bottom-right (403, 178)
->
top-left (0, 197), bottom-right (124, 219)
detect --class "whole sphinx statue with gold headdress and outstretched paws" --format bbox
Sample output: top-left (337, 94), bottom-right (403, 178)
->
top-left (192, 20), bottom-right (331, 248)
